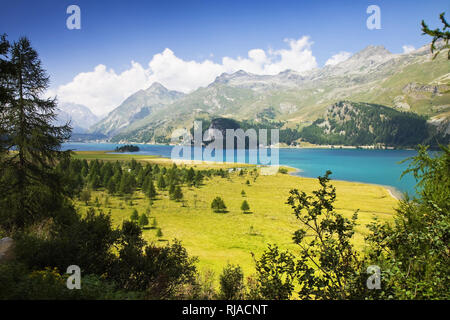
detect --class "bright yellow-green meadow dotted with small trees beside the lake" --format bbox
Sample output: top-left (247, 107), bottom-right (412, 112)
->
top-left (74, 152), bottom-right (397, 276)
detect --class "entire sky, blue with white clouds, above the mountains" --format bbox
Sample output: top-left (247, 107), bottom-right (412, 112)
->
top-left (0, 0), bottom-right (450, 115)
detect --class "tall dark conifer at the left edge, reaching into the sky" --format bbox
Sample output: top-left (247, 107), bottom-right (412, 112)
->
top-left (0, 38), bottom-right (71, 229)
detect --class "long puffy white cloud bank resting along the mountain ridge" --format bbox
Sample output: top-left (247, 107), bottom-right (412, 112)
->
top-left (48, 36), bottom-right (317, 115)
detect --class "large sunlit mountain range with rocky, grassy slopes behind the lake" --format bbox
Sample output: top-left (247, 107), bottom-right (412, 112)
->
top-left (65, 46), bottom-right (450, 143)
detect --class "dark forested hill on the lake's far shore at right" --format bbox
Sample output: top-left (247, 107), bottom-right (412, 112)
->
top-left (301, 101), bottom-right (449, 147)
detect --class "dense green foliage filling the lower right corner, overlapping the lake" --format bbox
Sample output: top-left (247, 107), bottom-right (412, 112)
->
top-left (367, 146), bottom-right (450, 300)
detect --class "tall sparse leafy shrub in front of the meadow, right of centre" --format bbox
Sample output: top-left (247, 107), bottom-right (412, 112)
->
top-left (287, 171), bottom-right (363, 300)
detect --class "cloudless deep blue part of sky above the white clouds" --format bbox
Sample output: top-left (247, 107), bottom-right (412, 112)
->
top-left (0, 0), bottom-right (450, 114)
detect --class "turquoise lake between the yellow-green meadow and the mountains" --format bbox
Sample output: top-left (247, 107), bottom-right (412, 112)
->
top-left (63, 143), bottom-right (417, 194)
